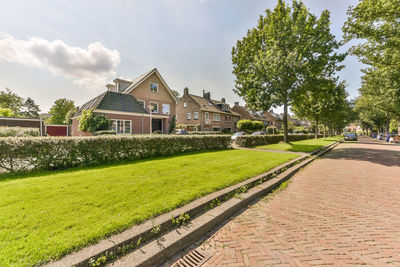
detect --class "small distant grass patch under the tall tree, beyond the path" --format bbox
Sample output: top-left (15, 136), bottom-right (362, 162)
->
top-left (254, 136), bottom-right (343, 152)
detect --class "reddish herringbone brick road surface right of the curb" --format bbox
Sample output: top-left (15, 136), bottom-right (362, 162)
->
top-left (173, 138), bottom-right (400, 266)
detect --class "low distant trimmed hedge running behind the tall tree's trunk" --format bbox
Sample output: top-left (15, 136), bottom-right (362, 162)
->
top-left (236, 134), bottom-right (323, 147)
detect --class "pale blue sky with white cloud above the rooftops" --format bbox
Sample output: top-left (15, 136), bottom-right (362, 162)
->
top-left (0, 0), bottom-right (363, 112)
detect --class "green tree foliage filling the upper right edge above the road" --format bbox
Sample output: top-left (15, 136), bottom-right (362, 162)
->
top-left (343, 0), bottom-right (400, 126)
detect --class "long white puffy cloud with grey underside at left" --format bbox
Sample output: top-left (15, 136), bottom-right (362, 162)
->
top-left (0, 34), bottom-right (121, 88)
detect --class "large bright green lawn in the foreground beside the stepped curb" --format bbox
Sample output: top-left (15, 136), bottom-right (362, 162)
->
top-left (0, 150), bottom-right (297, 266)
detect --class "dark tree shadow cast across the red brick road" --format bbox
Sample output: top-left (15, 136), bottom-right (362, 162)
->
top-left (324, 146), bottom-right (400, 169)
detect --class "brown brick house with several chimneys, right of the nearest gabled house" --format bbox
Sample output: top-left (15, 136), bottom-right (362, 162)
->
top-left (176, 88), bottom-right (240, 132)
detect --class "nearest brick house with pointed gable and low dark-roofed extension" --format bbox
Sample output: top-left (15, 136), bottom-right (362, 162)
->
top-left (72, 68), bottom-right (176, 136)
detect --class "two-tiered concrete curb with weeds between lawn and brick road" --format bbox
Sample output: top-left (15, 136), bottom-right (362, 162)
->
top-left (46, 142), bottom-right (339, 266)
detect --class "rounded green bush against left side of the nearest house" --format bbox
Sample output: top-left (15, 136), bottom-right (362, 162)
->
top-left (78, 109), bottom-right (111, 133)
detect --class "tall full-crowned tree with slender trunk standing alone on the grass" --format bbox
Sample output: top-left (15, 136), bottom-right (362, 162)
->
top-left (232, 0), bottom-right (345, 142)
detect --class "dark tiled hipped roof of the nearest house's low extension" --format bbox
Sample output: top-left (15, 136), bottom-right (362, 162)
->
top-left (77, 91), bottom-right (147, 116)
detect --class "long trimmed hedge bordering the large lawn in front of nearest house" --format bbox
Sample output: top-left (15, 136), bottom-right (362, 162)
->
top-left (0, 135), bottom-right (230, 172)
